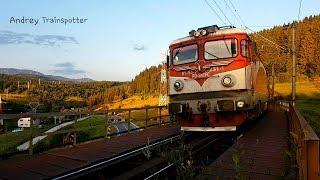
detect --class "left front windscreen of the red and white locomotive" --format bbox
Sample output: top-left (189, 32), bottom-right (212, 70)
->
top-left (172, 44), bottom-right (198, 65)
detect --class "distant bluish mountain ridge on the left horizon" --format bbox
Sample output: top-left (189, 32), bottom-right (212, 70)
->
top-left (0, 68), bottom-right (94, 82)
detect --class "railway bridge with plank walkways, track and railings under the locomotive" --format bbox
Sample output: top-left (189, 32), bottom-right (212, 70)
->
top-left (0, 102), bottom-right (320, 179)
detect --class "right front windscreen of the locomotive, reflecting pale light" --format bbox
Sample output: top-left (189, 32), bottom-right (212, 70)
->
top-left (204, 39), bottom-right (237, 60)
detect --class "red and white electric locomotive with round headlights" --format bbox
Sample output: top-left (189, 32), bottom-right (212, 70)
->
top-left (167, 25), bottom-right (269, 131)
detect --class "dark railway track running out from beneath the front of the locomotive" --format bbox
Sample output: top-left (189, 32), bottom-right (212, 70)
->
top-left (54, 114), bottom-right (264, 179)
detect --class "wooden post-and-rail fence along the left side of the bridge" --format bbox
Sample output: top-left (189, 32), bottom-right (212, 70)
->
top-left (0, 106), bottom-right (171, 157)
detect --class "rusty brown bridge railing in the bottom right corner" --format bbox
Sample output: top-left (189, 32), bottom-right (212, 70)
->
top-left (288, 103), bottom-right (320, 179)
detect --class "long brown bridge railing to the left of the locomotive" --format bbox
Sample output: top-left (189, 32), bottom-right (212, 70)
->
top-left (0, 106), bottom-right (171, 158)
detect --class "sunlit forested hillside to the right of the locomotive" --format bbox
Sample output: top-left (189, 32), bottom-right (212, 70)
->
top-left (252, 15), bottom-right (320, 81)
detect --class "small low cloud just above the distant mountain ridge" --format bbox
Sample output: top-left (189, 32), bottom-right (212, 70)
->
top-left (52, 62), bottom-right (86, 75)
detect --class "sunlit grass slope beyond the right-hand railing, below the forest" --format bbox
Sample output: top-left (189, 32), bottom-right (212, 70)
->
top-left (275, 80), bottom-right (320, 137)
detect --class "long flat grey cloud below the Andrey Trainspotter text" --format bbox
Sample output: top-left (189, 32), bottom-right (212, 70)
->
top-left (0, 31), bottom-right (78, 46)
